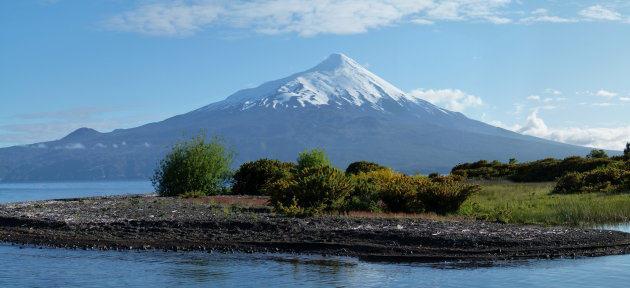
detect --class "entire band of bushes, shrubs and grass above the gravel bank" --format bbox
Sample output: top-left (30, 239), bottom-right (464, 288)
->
top-left (152, 134), bottom-right (630, 225)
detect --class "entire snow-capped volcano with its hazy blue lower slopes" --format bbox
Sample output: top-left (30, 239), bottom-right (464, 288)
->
top-left (0, 54), bottom-right (589, 181)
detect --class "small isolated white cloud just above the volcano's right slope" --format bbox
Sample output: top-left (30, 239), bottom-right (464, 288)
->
top-left (409, 89), bottom-right (483, 112)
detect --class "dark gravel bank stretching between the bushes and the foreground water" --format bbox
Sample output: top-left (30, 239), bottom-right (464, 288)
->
top-left (0, 195), bottom-right (630, 261)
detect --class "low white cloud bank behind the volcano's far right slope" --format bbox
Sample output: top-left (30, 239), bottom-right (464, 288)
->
top-left (508, 109), bottom-right (630, 150)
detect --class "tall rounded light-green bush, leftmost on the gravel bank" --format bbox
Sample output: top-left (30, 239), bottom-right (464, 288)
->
top-left (151, 131), bottom-right (235, 196)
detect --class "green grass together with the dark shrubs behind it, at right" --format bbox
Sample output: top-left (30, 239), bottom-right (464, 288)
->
top-left (453, 143), bottom-right (630, 226)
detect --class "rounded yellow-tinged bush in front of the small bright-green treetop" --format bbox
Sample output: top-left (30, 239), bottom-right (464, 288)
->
top-left (267, 166), bottom-right (353, 215)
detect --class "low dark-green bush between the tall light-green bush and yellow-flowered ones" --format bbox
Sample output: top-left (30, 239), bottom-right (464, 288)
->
top-left (232, 159), bottom-right (295, 195)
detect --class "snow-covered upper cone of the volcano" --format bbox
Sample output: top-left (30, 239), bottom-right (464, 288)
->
top-left (198, 53), bottom-right (447, 112)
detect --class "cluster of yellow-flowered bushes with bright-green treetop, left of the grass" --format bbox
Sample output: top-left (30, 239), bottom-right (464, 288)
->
top-left (262, 149), bottom-right (480, 216)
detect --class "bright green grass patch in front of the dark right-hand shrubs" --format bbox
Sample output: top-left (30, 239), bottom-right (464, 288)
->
top-left (458, 182), bottom-right (630, 227)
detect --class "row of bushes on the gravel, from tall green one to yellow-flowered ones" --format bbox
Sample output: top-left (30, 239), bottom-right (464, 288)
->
top-left (152, 134), bottom-right (480, 216)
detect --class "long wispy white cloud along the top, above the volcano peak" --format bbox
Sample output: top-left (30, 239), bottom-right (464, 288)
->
top-left (104, 0), bottom-right (511, 37)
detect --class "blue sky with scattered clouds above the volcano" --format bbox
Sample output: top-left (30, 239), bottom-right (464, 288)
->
top-left (0, 0), bottom-right (630, 150)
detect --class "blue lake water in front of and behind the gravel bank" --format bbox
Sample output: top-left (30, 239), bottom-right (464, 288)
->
top-left (0, 181), bottom-right (630, 287)
